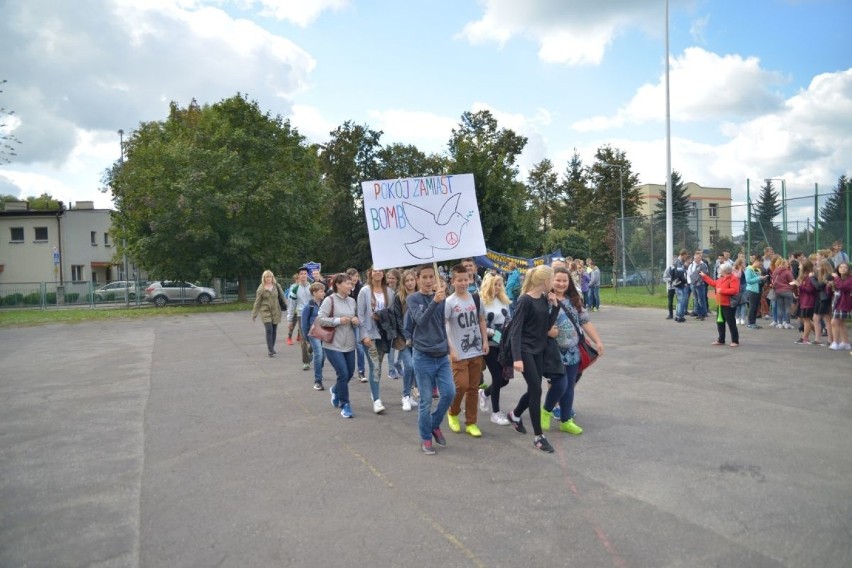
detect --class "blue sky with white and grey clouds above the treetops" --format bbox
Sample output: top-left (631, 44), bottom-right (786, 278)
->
top-left (0, 0), bottom-right (852, 226)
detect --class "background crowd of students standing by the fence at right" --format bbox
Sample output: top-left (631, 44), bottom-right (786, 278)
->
top-left (663, 241), bottom-right (852, 354)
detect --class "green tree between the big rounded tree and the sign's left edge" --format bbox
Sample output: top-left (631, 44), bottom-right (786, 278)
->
top-left (316, 121), bottom-right (382, 270)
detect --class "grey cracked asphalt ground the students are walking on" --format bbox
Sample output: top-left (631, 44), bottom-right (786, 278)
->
top-left (0, 307), bottom-right (852, 568)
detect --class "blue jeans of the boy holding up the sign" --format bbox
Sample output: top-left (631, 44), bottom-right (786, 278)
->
top-left (412, 349), bottom-right (456, 442)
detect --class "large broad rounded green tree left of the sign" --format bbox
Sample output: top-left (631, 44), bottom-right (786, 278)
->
top-left (104, 93), bottom-right (326, 291)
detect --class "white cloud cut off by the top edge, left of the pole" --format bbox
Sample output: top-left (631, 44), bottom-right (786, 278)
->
top-left (461, 0), bottom-right (663, 65)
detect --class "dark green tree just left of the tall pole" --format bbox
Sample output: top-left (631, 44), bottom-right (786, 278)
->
top-left (578, 145), bottom-right (639, 266)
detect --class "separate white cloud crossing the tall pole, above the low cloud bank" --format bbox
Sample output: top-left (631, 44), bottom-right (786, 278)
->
top-left (572, 47), bottom-right (785, 132)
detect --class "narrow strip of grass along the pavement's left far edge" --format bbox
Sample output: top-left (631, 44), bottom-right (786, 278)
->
top-left (0, 302), bottom-right (252, 328)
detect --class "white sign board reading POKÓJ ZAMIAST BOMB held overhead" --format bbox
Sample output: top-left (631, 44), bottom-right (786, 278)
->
top-left (361, 174), bottom-right (486, 268)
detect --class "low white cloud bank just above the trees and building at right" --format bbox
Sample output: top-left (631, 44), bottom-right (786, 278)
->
top-left (557, 69), bottom-right (852, 218)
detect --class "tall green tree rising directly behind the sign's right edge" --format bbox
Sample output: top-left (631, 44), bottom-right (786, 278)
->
top-left (449, 110), bottom-right (535, 254)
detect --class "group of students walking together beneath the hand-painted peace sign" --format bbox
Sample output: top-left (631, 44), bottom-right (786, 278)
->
top-left (252, 259), bottom-right (604, 455)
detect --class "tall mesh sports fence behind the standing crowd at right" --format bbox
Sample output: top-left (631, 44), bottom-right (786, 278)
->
top-left (613, 184), bottom-right (852, 293)
